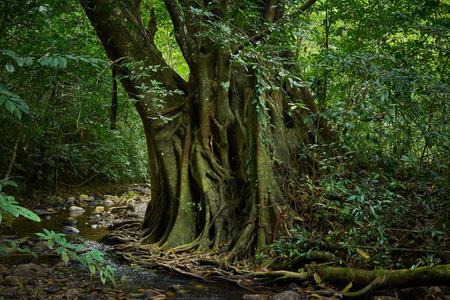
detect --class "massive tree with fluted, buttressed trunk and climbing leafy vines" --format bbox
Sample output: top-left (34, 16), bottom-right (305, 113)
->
top-left (81, 0), bottom-right (334, 262)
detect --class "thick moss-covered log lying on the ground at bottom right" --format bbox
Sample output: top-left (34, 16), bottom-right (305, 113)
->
top-left (316, 265), bottom-right (450, 288)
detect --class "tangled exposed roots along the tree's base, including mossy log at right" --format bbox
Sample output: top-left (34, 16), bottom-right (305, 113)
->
top-left (100, 189), bottom-right (450, 298)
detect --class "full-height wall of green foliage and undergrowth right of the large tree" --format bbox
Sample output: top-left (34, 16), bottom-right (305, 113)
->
top-left (266, 0), bottom-right (450, 268)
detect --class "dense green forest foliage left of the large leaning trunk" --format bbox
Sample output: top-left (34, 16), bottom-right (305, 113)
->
top-left (0, 1), bottom-right (147, 191)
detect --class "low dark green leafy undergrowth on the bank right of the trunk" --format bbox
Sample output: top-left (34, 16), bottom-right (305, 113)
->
top-left (268, 149), bottom-right (450, 269)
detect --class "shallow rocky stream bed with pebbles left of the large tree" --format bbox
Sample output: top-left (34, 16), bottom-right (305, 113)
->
top-left (0, 186), bottom-right (250, 299)
